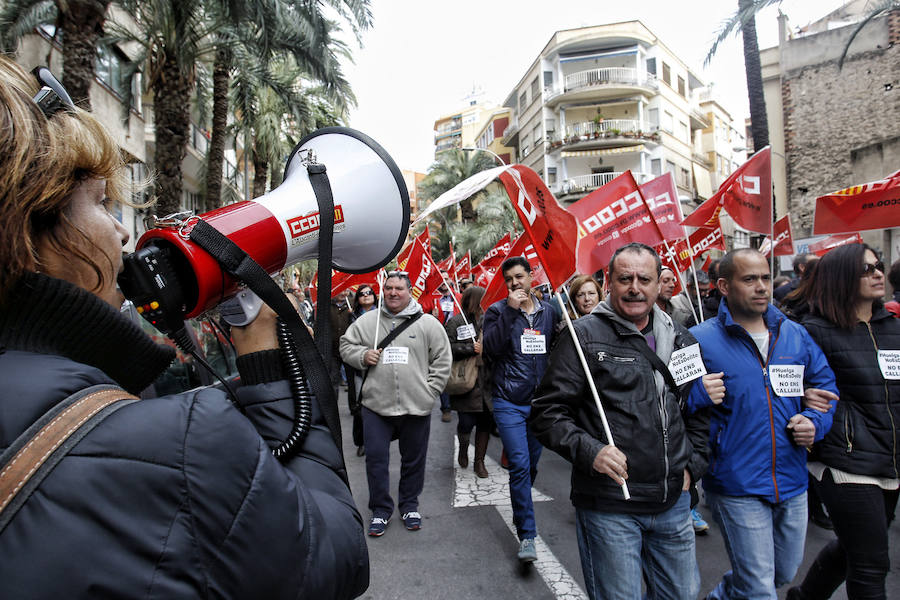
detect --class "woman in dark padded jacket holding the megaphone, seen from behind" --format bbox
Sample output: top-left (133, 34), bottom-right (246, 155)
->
top-left (0, 58), bottom-right (368, 598)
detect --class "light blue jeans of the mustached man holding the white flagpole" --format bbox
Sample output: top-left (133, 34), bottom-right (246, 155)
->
top-left (575, 492), bottom-right (700, 600)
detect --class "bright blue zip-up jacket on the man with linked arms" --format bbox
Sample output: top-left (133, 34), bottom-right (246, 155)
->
top-left (688, 302), bottom-right (838, 502)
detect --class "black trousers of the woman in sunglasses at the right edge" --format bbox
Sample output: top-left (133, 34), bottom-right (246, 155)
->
top-left (800, 469), bottom-right (900, 600)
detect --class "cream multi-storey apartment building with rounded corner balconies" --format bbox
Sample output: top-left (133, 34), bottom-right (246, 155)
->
top-left (501, 21), bottom-right (743, 212)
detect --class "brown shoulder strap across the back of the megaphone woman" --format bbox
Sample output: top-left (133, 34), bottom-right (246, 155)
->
top-left (0, 386), bottom-right (139, 531)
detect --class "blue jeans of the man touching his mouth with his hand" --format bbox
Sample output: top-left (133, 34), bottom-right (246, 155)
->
top-left (494, 398), bottom-right (543, 540)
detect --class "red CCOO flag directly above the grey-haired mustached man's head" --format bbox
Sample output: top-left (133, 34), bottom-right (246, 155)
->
top-left (569, 171), bottom-right (662, 273)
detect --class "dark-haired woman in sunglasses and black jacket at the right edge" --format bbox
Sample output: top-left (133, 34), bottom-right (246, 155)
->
top-left (787, 244), bottom-right (900, 600)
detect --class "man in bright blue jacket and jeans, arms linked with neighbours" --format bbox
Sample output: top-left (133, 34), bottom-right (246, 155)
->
top-left (688, 248), bottom-right (837, 599)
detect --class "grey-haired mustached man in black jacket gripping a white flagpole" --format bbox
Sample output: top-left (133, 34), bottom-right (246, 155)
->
top-left (531, 243), bottom-right (707, 600)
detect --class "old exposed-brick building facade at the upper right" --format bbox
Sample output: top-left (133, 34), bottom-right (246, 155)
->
top-left (760, 2), bottom-right (900, 264)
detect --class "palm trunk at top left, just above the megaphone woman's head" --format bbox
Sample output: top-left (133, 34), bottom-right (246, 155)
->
top-left (57, 0), bottom-right (109, 110)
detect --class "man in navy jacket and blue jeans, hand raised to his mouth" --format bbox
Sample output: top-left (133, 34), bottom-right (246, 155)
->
top-left (483, 256), bottom-right (557, 563)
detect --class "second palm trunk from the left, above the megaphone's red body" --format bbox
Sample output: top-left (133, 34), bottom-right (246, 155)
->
top-left (153, 54), bottom-right (193, 216)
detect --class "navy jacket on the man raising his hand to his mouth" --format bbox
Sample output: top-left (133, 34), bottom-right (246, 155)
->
top-left (482, 296), bottom-right (557, 404)
